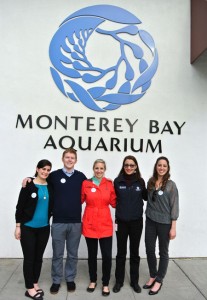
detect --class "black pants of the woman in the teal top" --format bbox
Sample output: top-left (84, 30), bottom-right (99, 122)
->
top-left (20, 225), bottom-right (50, 289)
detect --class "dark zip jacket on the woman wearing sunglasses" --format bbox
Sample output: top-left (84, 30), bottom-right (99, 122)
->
top-left (114, 175), bottom-right (147, 222)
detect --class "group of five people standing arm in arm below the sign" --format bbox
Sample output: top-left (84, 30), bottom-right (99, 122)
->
top-left (15, 148), bottom-right (179, 300)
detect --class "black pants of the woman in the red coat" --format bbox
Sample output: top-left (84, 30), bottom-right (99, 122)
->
top-left (86, 236), bottom-right (112, 286)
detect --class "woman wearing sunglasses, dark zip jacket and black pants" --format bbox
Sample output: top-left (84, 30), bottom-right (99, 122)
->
top-left (113, 155), bottom-right (147, 293)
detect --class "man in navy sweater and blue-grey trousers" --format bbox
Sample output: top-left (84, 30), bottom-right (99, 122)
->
top-left (48, 148), bottom-right (86, 294)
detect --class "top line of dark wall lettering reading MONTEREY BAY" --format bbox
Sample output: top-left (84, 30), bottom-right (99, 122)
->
top-left (16, 114), bottom-right (185, 135)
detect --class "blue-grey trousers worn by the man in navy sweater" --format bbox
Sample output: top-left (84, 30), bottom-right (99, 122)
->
top-left (51, 223), bottom-right (81, 284)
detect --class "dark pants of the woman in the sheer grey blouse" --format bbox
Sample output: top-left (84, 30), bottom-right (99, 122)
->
top-left (145, 218), bottom-right (171, 282)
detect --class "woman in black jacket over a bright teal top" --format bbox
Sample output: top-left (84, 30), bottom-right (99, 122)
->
top-left (15, 159), bottom-right (53, 300)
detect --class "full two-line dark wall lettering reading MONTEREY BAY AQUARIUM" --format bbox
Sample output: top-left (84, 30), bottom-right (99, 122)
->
top-left (16, 114), bottom-right (185, 153)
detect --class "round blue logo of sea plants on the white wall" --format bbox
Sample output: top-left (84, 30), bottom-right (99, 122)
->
top-left (49, 5), bottom-right (158, 112)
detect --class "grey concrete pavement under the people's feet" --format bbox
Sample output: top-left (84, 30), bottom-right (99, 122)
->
top-left (0, 258), bottom-right (207, 300)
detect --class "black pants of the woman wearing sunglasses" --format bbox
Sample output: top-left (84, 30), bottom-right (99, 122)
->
top-left (115, 218), bottom-right (143, 284)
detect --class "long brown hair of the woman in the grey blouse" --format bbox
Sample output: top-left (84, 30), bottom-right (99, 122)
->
top-left (147, 156), bottom-right (170, 191)
